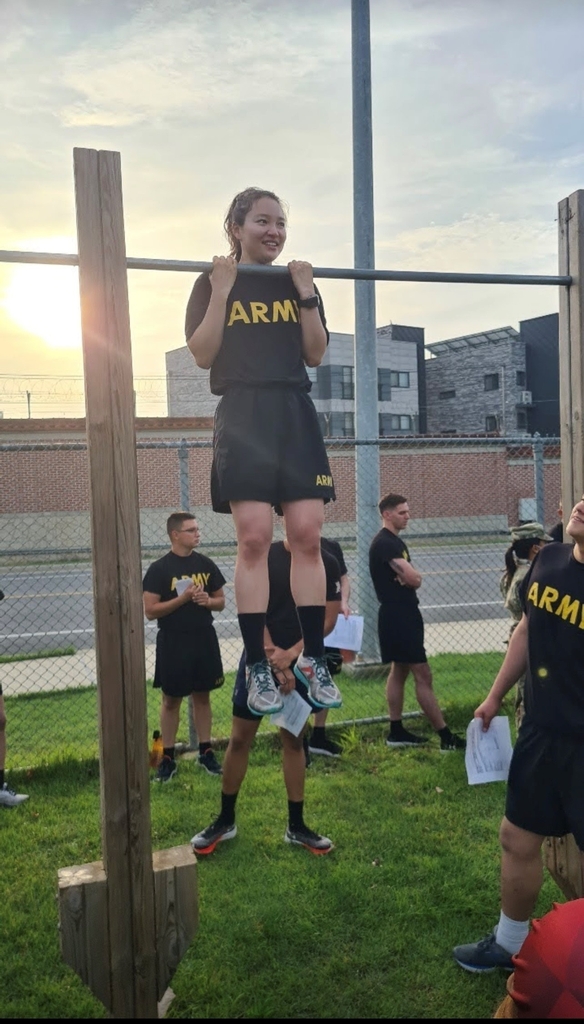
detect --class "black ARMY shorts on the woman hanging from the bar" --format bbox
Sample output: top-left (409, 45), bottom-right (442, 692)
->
top-left (211, 386), bottom-right (335, 514)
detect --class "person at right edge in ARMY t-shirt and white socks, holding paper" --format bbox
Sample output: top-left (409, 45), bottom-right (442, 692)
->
top-left (453, 498), bottom-right (584, 972)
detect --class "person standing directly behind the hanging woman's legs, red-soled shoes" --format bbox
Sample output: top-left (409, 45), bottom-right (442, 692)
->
top-left (191, 541), bottom-right (340, 854)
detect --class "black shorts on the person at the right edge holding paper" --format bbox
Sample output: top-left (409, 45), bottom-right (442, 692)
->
top-left (505, 718), bottom-right (584, 851)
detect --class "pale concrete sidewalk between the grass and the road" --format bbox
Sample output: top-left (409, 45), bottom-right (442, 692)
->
top-left (0, 618), bottom-right (509, 696)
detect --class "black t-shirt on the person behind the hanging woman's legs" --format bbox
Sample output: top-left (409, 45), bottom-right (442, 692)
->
top-left (266, 541), bottom-right (341, 650)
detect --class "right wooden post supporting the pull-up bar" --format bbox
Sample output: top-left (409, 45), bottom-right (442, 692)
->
top-left (544, 189), bottom-right (584, 899)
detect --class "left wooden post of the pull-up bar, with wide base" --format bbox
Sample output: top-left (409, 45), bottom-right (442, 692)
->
top-left (59, 150), bottom-right (196, 1018)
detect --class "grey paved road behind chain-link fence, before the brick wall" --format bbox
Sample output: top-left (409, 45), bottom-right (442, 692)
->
top-left (0, 542), bottom-right (508, 654)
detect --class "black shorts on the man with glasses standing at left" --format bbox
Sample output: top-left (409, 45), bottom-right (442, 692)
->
top-left (154, 626), bottom-right (224, 697)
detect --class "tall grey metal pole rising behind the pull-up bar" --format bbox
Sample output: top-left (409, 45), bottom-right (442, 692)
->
top-left (351, 0), bottom-right (380, 662)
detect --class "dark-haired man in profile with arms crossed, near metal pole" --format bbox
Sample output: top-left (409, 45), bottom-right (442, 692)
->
top-left (369, 494), bottom-right (466, 751)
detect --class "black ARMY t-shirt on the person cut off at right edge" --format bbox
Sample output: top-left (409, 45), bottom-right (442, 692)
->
top-left (520, 544), bottom-right (584, 734)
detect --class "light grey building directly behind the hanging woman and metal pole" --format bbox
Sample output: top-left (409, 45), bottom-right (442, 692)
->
top-left (166, 324), bottom-right (426, 437)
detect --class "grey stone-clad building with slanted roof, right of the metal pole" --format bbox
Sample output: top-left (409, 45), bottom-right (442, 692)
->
top-left (425, 327), bottom-right (532, 437)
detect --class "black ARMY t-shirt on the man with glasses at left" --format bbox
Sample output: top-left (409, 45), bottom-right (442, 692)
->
top-left (142, 551), bottom-right (225, 633)
